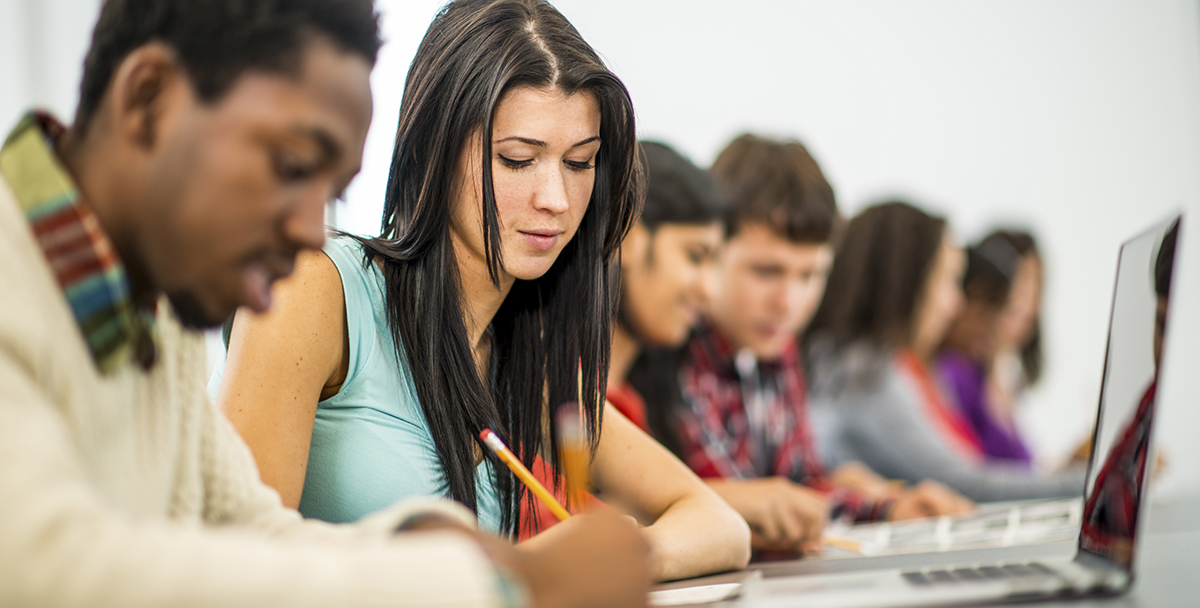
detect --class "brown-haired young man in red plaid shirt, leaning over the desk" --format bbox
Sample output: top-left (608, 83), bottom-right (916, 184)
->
top-left (630, 134), bottom-right (966, 552)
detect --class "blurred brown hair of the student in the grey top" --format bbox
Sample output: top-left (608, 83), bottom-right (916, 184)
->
top-left (806, 200), bottom-right (946, 348)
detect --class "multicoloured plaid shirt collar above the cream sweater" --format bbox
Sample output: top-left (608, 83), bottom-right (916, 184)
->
top-left (0, 113), bottom-right (157, 373)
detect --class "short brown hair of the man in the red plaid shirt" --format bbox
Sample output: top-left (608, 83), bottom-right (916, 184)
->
top-left (710, 133), bottom-right (839, 243)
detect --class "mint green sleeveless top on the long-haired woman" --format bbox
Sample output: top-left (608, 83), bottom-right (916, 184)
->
top-left (209, 237), bottom-right (500, 532)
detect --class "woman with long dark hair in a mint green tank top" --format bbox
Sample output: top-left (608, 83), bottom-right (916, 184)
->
top-left (217, 0), bottom-right (749, 579)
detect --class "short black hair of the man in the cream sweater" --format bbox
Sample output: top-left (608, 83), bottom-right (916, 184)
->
top-left (74, 0), bottom-right (380, 132)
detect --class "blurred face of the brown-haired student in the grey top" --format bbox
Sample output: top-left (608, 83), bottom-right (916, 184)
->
top-left (910, 234), bottom-right (966, 357)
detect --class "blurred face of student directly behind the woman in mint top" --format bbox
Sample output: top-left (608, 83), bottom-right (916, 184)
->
top-left (620, 222), bottom-right (722, 347)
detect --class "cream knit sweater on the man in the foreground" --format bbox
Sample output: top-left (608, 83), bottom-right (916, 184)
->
top-left (0, 177), bottom-right (500, 608)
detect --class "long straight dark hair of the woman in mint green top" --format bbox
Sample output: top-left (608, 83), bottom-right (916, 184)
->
top-left (350, 0), bottom-right (644, 532)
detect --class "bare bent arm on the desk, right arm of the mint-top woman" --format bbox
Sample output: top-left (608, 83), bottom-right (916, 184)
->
top-left (592, 407), bottom-right (750, 580)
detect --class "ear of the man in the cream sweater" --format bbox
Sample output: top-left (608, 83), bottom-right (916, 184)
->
top-left (110, 42), bottom-right (191, 150)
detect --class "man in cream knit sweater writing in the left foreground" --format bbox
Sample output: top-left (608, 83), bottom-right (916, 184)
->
top-left (0, 0), bottom-right (648, 608)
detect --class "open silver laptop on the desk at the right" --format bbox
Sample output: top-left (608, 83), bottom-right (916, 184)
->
top-left (650, 216), bottom-right (1180, 608)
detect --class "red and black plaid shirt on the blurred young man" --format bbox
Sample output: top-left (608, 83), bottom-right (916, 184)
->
top-left (677, 323), bottom-right (890, 522)
